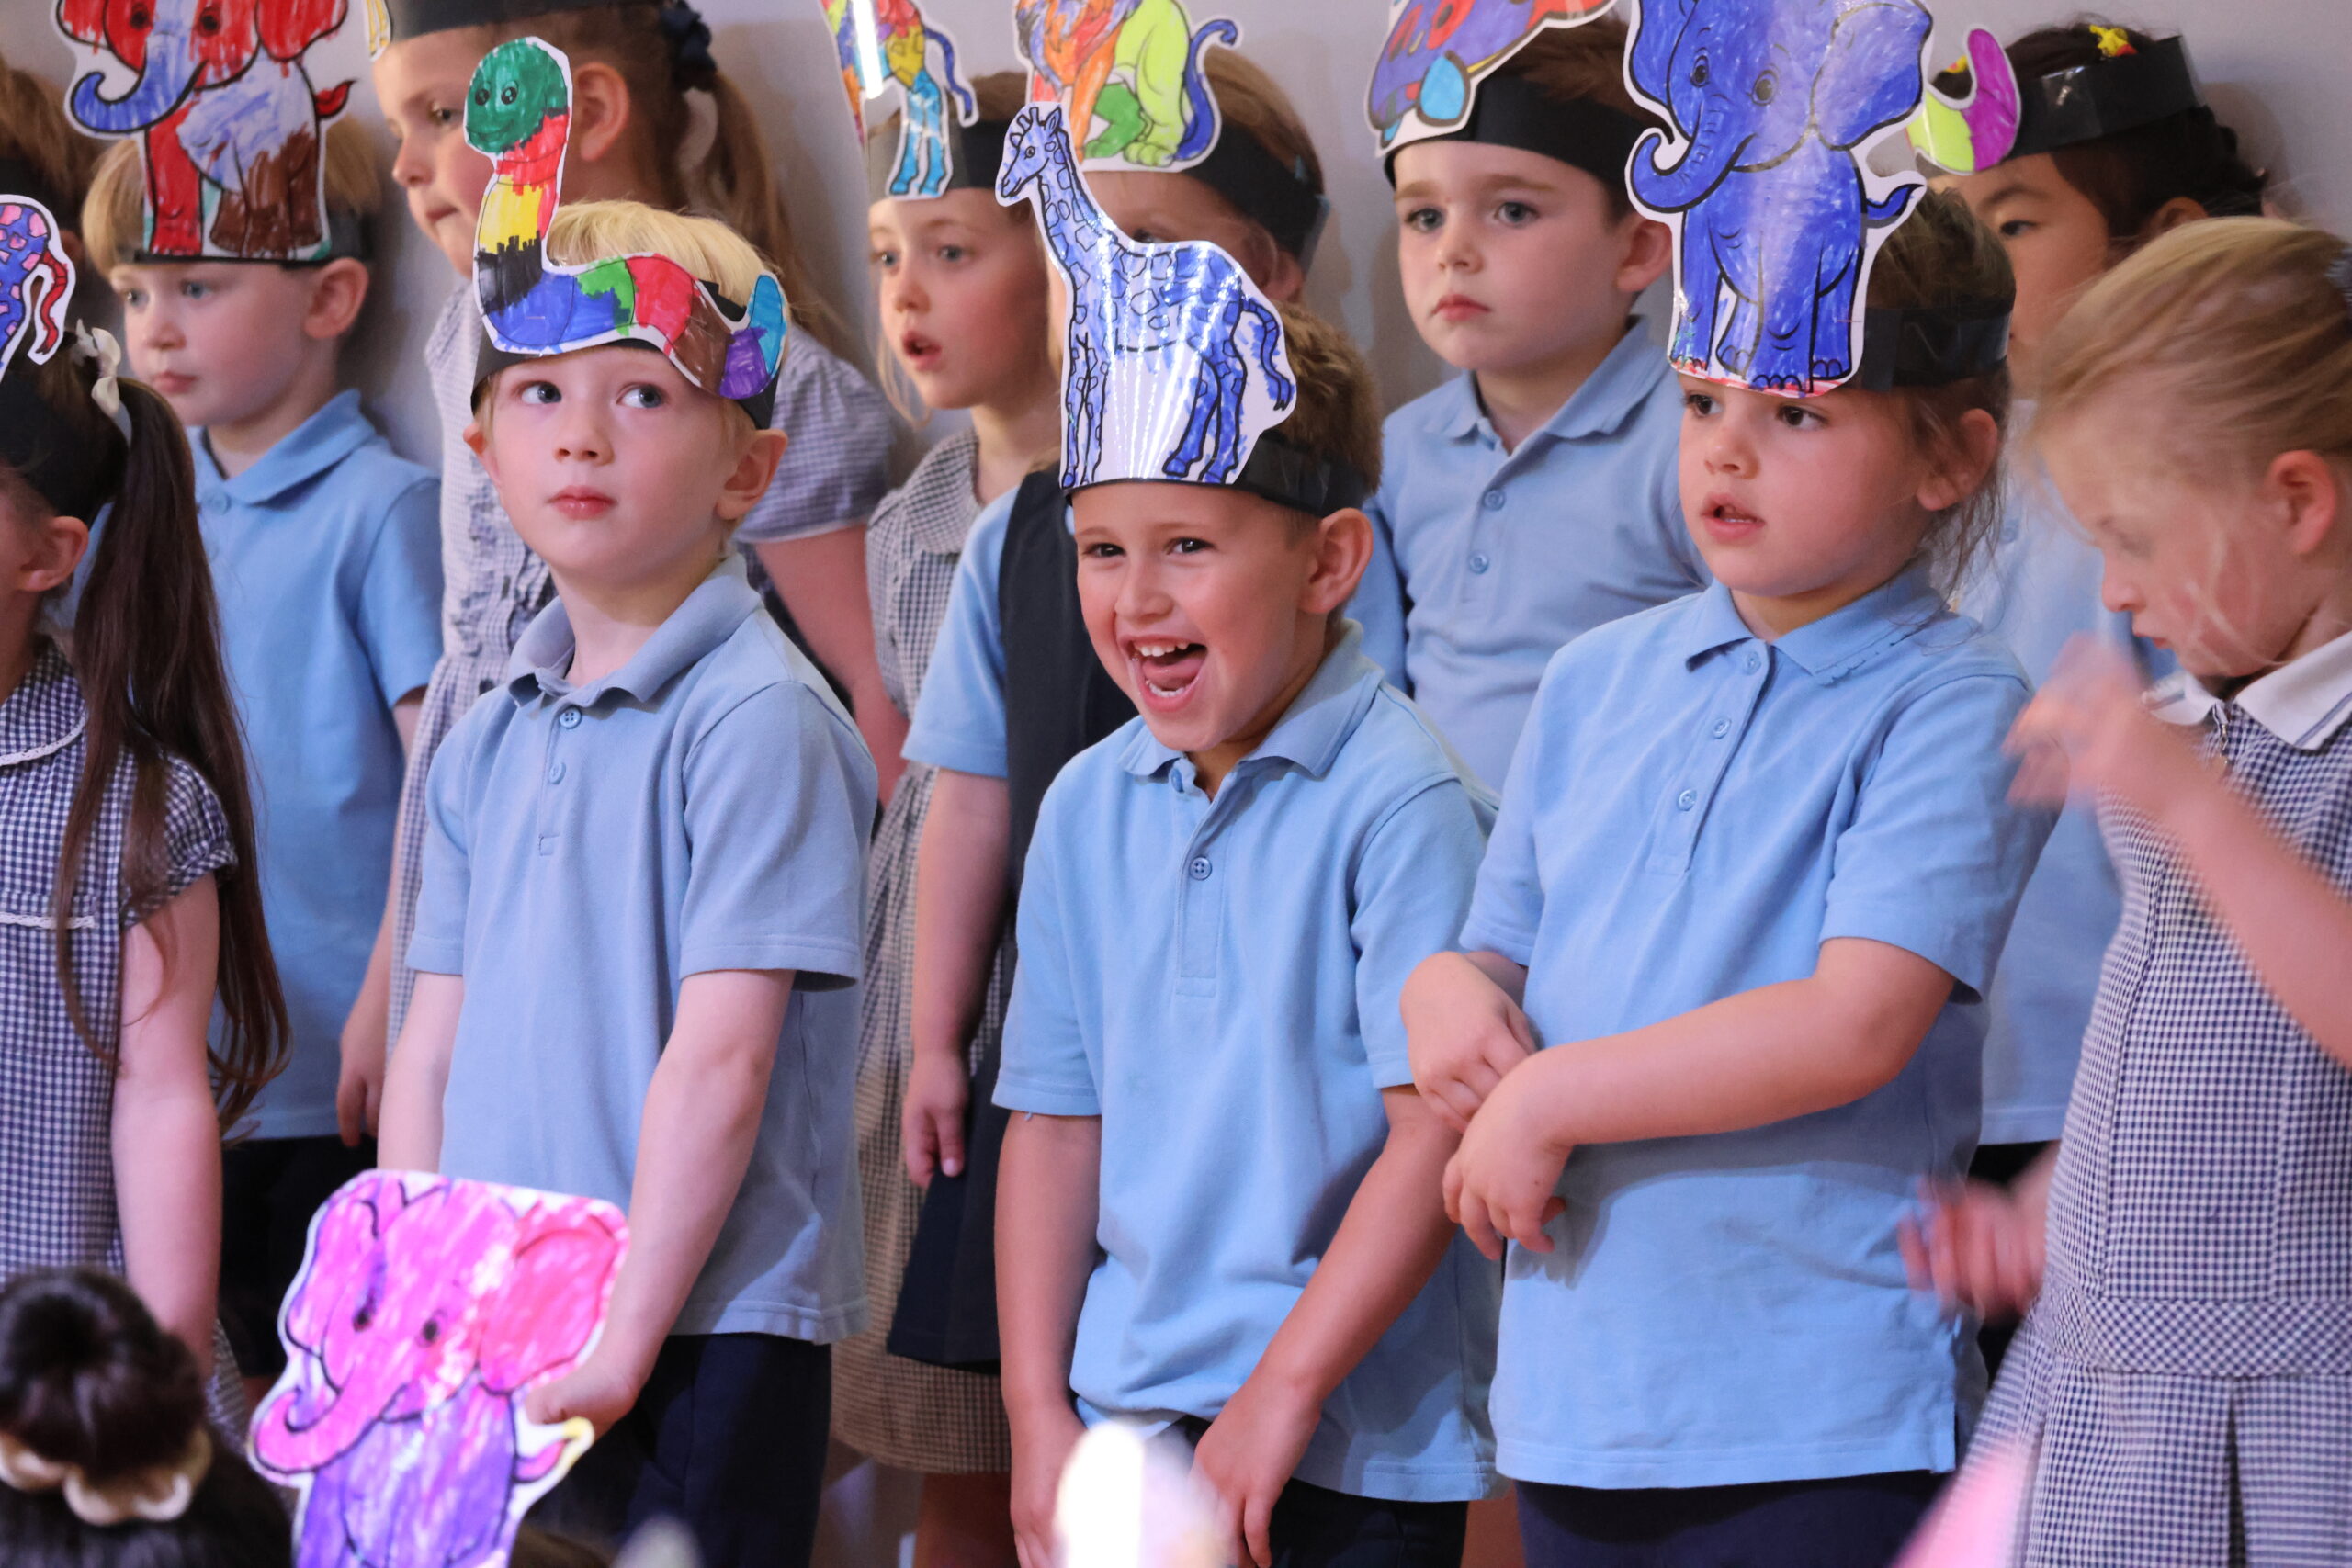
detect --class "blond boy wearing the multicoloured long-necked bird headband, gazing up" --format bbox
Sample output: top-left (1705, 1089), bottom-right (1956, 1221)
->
top-left (383, 199), bottom-right (875, 1568)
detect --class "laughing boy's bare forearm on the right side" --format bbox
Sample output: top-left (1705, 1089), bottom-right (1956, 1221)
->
top-left (1251, 1089), bottom-right (1458, 1405)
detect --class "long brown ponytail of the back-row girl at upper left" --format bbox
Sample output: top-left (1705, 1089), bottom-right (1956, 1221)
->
top-left (480, 3), bottom-right (847, 353)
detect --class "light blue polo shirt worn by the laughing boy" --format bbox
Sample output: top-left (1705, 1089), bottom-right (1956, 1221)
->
top-left (997, 630), bottom-right (1500, 1502)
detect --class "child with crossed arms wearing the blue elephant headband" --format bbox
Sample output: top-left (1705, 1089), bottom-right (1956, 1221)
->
top-left (1404, 195), bottom-right (2049, 1568)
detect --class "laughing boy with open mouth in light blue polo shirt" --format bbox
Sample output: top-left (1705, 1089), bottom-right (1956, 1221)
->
top-left (997, 308), bottom-right (1498, 1568)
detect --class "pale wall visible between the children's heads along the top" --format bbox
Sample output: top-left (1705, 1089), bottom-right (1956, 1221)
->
top-left (18, 0), bottom-right (2352, 472)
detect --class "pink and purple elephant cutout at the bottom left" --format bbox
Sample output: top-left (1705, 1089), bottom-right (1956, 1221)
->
top-left (252, 1170), bottom-right (628, 1568)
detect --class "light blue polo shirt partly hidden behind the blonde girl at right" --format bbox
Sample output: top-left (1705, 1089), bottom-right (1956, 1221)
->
top-left (1959, 478), bottom-right (2173, 1143)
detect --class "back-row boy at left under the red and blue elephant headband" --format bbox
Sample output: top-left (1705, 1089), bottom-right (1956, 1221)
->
top-left (83, 122), bottom-right (442, 1389)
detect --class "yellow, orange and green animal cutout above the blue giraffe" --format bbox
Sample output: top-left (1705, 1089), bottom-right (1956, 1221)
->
top-left (1013, 0), bottom-right (1242, 169)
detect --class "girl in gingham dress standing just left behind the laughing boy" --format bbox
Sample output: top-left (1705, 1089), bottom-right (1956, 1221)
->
top-left (832, 71), bottom-right (1061, 1563)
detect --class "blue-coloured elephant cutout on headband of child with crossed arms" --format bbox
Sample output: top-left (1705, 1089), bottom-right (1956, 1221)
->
top-left (1625, 0), bottom-right (1933, 398)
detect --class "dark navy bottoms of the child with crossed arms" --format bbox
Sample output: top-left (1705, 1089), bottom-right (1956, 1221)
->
top-left (1520, 1470), bottom-right (1945, 1568)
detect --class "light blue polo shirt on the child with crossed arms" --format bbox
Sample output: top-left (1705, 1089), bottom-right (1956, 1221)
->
top-left (1458, 569), bottom-right (2049, 1488)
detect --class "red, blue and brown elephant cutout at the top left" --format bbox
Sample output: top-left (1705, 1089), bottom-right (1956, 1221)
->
top-left (56, 0), bottom-right (362, 264)
